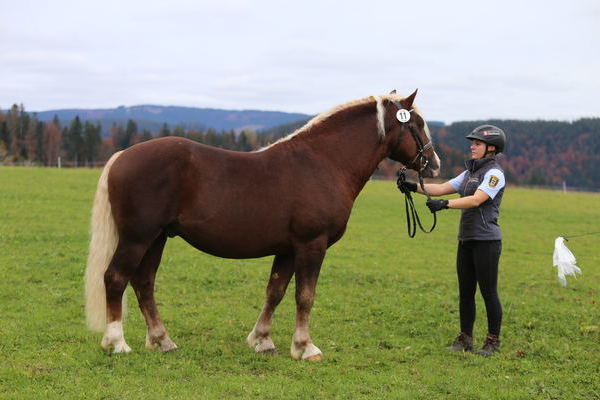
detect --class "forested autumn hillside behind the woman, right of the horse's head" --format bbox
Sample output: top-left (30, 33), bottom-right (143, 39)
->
top-left (431, 118), bottom-right (600, 190)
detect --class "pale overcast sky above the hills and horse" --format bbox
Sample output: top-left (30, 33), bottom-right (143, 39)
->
top-left (0, 0), bottom-right (600, 122)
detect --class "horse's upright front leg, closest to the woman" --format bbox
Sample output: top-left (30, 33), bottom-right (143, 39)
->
top-left (291, 238), bottom-right (327, 361)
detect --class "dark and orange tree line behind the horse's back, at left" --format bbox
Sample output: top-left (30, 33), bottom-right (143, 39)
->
top-left (0, 104), bottom-right (276, 166)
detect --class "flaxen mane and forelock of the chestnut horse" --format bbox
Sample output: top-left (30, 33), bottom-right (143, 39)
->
top-left (258, 94), bottom-right (429, 151)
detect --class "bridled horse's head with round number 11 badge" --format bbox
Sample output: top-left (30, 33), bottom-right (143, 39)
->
top-left (383, 90), bottom-right (440, 178)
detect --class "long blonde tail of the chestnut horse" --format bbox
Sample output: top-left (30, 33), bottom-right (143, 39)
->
top-left (85, 152), bottom-right (127, 332)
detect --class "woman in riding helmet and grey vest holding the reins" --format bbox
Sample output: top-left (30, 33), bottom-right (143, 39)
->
top-left (400, 125), bottom-right (506, 357)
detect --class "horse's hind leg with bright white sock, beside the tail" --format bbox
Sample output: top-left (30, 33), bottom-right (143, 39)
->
top-left (101, 240), bottom-right (148, 353)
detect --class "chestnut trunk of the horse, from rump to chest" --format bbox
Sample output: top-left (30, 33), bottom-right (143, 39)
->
top-left (109, 137), bottom-right (352, 258)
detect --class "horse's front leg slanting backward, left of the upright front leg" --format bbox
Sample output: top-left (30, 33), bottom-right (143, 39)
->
top-left (247, 255), bottom-right (294, 354)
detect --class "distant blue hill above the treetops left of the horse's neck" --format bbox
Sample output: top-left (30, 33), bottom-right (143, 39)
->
top-left (36, 105), bottom-right (310, 135)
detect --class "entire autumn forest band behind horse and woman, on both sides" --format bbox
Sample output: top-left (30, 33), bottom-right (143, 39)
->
top-left (0, 105), bottom-right (600, 191)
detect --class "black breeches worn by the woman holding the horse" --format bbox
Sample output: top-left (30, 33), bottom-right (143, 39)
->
top-left (456, 240), bottom-right (502, 335)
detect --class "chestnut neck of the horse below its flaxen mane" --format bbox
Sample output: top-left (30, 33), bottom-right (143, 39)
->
top-left (298, 103), bottom-right (387, 197)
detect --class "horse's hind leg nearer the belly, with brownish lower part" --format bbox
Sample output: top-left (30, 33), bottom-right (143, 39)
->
top-left (131, 234), bottom-right (177, 352)
